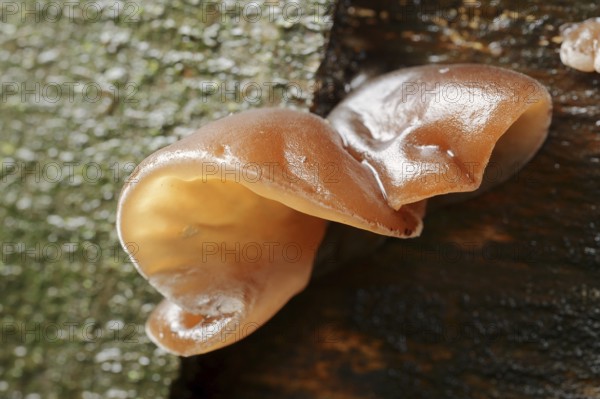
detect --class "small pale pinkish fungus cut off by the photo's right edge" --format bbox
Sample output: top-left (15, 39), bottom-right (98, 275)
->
top-left (560, 17), bottom-right (600, 73)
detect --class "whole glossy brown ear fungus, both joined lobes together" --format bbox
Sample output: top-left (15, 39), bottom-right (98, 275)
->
top-left (117, 65), bottom-right (551, 356)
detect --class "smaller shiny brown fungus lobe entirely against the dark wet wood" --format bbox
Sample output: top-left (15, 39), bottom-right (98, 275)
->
top-left (328, 64), bottom-right (552, 209)
